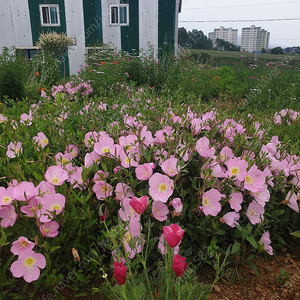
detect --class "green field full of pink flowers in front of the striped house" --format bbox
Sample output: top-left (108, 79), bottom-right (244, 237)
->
top-left (0, 47), bottom-right (300, 300)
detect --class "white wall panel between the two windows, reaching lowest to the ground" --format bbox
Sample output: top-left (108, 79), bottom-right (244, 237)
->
top-left (65, 0), bottom-right (85, 74)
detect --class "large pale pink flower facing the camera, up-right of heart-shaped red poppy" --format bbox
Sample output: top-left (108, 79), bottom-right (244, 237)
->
top-left (149, 173), bottom-right (173, 202)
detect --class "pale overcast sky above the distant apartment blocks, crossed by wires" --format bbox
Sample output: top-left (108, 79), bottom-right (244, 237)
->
top-left (179, 0), bottom-right (300, 48)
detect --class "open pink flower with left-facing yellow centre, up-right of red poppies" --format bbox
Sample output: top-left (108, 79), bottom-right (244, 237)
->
top-left (199, 189), bottom-right (225, 217)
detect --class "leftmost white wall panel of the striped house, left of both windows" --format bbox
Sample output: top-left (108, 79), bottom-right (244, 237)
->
top-left (0, 0), bottom-right (33, 48)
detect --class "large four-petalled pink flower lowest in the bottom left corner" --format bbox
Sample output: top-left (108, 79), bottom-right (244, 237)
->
top-left (10, 250), bottom-right (46, 282)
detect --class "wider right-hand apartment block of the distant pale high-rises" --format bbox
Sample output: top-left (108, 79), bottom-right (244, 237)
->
top-left (241, 25), bottom-right (270, 52)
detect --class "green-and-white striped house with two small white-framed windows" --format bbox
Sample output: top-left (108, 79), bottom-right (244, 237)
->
top-left (0, 0), bottom-right (182, 74)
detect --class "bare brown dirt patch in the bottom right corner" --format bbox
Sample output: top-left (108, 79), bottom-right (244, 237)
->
top-left (207, 244), bottom-right (300, 300)
